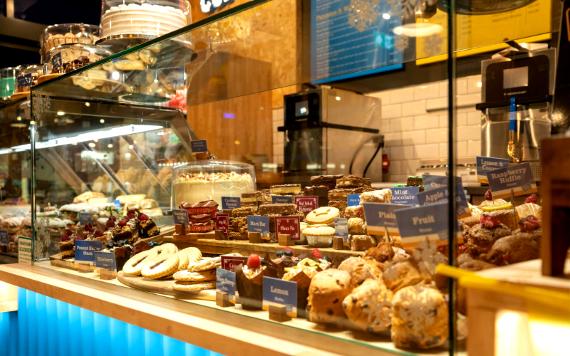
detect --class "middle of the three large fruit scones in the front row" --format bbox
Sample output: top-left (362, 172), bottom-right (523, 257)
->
top-left (342, 279), bottom-right (393, 334)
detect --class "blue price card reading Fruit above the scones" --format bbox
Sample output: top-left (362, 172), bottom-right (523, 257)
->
top-left (395, 203), bottom-right (448, 243)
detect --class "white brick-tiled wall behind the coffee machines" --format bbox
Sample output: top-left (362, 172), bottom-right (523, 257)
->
top-left (273, 75), bottom-right (481, 182)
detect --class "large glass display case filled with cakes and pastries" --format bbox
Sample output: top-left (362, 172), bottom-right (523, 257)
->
top-left (0, 0), bottom-right (555, 354)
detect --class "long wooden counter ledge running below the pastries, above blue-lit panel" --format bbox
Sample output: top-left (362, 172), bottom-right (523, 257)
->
top-left (0, 262), bottom-right (447, 355)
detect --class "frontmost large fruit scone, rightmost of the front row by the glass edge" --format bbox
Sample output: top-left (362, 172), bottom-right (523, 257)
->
top-left (391, 286), bottom-right (448, 349)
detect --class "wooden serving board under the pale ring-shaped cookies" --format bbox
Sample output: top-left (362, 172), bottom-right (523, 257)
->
top-left (117, 271), bottom-right (216, 301)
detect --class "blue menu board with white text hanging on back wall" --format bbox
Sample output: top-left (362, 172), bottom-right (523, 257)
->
top-left (311, 0), bottom-right (405, 84)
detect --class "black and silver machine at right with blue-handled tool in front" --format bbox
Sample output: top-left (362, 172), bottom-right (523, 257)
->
top-left (477, 48), bottom-right (555, 180)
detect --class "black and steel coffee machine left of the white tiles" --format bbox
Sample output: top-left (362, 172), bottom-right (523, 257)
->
top-left (278, 86), bottom-right (384, 182)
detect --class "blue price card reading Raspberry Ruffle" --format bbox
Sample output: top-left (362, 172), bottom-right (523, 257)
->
top-left (487, 162), bottom-right (537, 198)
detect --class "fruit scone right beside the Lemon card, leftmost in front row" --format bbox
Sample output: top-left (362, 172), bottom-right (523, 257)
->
top-left (307, 269), bottom-right (352, 324)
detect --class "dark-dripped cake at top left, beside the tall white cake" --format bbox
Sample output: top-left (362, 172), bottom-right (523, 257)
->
top-left (40, 23), bottom-right (101, 63)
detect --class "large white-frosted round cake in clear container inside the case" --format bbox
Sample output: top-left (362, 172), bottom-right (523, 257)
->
top-left (172, 161), bottom-right (255, 208)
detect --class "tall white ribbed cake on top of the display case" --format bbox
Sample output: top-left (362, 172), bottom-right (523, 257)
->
top-left (101, 0), bottom-right (191, 39)
